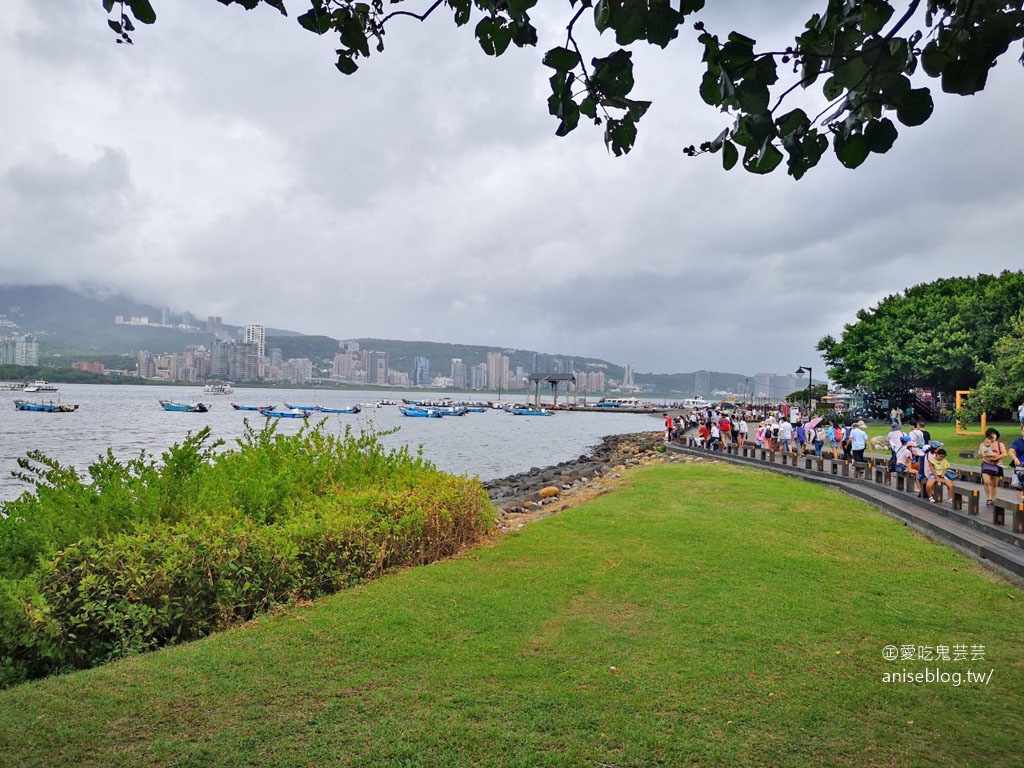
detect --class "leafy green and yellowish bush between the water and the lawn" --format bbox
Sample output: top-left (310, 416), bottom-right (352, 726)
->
top-left (0, 424), bottom-right (494, 686)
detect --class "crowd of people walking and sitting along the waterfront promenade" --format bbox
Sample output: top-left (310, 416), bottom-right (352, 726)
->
top-left (666, 407), bottom-right (1024, 507)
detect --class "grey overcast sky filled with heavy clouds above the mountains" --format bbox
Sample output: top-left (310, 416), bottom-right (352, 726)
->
top-left (0, 0), bottom-right (1024, 373)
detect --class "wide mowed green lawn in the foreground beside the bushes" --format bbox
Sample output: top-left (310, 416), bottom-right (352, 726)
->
top-left (0, 462), bottom-right (1024, 768)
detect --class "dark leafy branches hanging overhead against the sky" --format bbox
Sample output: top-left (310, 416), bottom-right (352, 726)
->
top-left (102, 0), bottom-right (1024, 178)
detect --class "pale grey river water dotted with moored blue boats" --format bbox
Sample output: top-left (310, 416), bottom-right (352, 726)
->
top-left (0, 384), bottom-right (662, 502)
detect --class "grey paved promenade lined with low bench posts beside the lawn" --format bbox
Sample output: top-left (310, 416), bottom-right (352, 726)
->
top-left (667, 442), bottom-right (1024, 586)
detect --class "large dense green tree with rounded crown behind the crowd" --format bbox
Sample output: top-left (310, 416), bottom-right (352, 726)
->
top-left (817, 271), bottom-right (1024, 392)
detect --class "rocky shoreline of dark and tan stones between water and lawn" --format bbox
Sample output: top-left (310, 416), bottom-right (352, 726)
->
top-left (483, 431), bottom-right (688, 528)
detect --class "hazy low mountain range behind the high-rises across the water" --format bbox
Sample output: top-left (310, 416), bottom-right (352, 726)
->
top-left (0, 286), bottom-right (751, 394)
